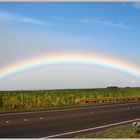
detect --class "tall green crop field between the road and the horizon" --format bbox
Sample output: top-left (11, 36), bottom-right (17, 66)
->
top-left (0, 87), bottom-right (140, 111)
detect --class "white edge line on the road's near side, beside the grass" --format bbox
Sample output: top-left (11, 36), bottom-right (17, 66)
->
top-left (46, 118), bottom-right (140, 138)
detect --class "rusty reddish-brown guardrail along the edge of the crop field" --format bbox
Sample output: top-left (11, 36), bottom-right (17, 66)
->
top-left (77, 96), bottom-right (140, 104)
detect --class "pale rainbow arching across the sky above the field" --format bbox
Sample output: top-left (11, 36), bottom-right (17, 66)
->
top-left (0, 53), bottom-right (140, 79)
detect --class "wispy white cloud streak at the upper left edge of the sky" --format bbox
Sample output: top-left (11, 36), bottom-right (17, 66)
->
top-left (0, 11), bottom-right (50, 26)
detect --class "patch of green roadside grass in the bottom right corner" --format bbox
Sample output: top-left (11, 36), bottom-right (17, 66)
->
top-left (79, 124), bottom-right (140, 138)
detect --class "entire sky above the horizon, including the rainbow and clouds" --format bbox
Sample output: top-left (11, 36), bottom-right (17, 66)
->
top-left (0, 2), bottom-right (140, 90)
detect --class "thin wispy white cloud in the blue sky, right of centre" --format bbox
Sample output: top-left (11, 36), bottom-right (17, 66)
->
top-left (80, 19), bottom-right (132, 29)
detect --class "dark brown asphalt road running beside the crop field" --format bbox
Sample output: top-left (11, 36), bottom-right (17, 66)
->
top-left (0, 102), bottom-right (140, 138)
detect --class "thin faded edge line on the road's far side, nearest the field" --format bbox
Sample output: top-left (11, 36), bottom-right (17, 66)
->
top-left (0, 102), bottom-right (139, 116)
